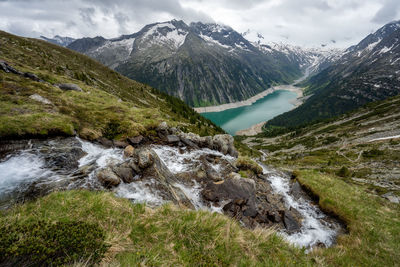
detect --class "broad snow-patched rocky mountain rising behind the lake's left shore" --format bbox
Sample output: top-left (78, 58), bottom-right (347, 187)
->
top-left (68, 20), bottom-right (301, 106)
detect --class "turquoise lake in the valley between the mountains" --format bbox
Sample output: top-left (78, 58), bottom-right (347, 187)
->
top-left (201, 90), bottom-right (297, 135)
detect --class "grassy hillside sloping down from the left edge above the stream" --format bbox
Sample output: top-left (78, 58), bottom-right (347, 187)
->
top-left (0, 32), bottom-right (222, 139)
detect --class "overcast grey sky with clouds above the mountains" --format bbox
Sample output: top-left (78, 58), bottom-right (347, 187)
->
top-left (0, 0), bottom-right (400, 47)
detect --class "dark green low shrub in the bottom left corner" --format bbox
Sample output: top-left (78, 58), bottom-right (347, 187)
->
top-left (0, 220), bottom-right (108, 266)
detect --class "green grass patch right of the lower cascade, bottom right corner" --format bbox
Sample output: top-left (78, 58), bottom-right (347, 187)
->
top-left (296, 170), bottom-right (400, 266)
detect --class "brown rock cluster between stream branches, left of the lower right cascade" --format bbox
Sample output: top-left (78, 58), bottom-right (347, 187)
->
top-left (202, 175), bottom-right (301, 232)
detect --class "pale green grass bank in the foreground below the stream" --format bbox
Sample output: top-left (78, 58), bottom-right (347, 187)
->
top-left (0, 191), bottom-right (316, 266)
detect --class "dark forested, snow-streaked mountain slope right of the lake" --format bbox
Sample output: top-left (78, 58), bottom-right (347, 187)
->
top-left (269, 21), bottom-right (400, 127)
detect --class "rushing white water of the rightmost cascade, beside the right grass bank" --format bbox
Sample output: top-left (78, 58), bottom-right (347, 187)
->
top-left (260, 164), bottom-right (337, 248)
